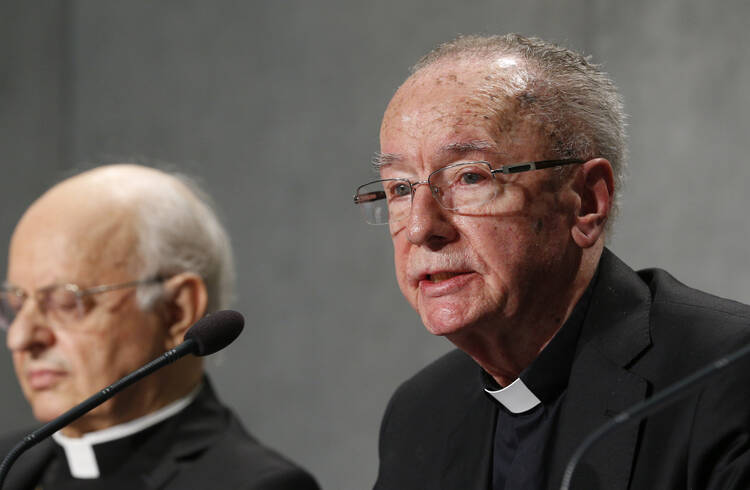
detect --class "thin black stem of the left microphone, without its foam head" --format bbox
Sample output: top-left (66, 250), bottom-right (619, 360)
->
top-left (0, 339), bottom-right (197, 488)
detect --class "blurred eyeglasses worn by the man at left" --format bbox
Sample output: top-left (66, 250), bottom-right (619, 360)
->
top-left (0, 277), bottom-right (164, 330)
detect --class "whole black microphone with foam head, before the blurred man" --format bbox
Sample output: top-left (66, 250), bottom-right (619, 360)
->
top-left (0, 310), bottom-right (245, 488)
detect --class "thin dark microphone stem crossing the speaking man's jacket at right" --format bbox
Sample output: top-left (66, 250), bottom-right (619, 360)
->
top-left (560, 345), bottom-right (750, 490)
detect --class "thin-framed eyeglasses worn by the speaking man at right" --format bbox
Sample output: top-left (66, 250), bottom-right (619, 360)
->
top-left (354, 159), bottom-right (584, 225)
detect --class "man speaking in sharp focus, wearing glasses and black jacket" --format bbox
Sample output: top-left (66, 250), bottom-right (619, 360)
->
top-left (355, 35), bottom-right (750, 490)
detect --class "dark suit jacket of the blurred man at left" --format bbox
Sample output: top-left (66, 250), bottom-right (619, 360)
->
top-left (0, 380), bottom-right (318, 490)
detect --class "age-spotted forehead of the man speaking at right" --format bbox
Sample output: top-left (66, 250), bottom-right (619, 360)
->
top-left (380, 58), bottom-right (541, 167)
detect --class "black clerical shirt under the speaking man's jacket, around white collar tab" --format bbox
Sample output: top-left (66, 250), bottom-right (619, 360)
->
top-left (482, 278), bottom-right (596, 490)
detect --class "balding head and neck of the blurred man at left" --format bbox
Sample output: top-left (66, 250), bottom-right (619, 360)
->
top-left (7, 164), bottom-right (232, 434)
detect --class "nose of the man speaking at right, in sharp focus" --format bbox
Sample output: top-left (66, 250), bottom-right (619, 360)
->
top-left (406, 185), bottom-right (458, 250)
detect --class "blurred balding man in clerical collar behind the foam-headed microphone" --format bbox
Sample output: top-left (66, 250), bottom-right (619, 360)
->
top-left (0, 165), bottom-right (318, 490)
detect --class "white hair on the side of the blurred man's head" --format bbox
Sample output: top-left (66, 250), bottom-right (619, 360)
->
top-left (130, 173), bottom-right (235, 313)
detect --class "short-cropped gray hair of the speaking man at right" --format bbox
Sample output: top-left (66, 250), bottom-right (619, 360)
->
top-left (412, 34), bottom-right (627, 225)
